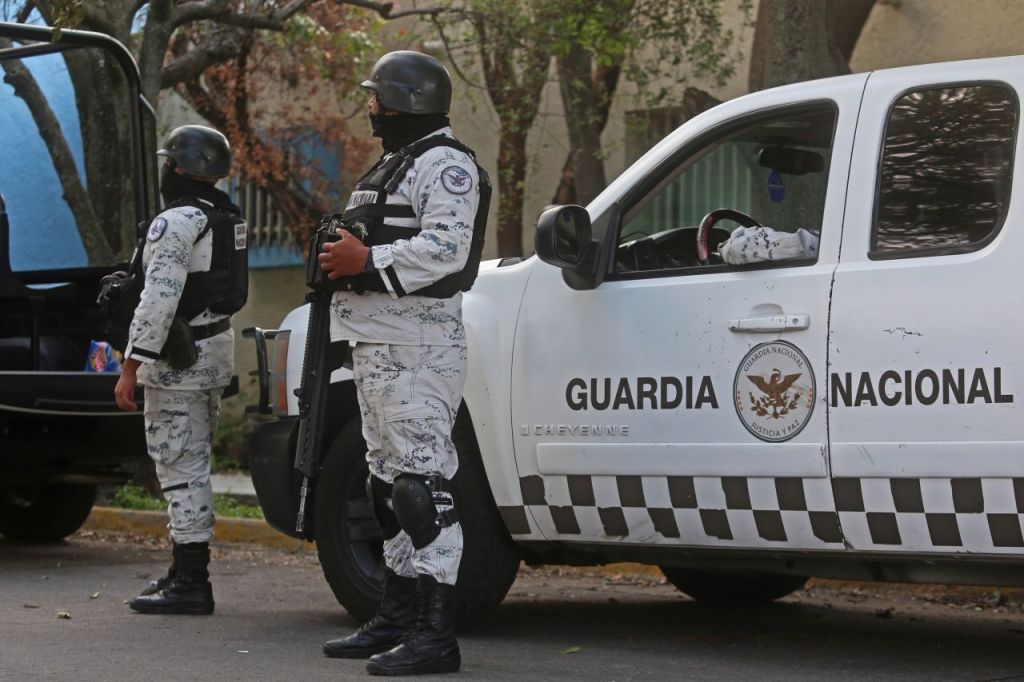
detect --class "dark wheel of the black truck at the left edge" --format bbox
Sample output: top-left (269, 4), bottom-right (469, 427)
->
top-left (0, 483), bottom-right (96, 543)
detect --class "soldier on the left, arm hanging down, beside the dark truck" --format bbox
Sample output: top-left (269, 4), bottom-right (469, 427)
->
top-left (115, 126), bottom-right (245, 614)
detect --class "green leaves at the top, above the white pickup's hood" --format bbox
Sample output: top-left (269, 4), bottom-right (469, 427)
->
top-left (438, 0), bottom-right (753, 109)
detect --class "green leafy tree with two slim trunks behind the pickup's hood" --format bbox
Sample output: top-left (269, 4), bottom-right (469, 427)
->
top-left (434, 0), bottom-right (746, 256)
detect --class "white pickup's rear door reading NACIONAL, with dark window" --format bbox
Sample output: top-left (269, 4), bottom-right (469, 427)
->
top-left (827, 57), bottom-right (1024, 553)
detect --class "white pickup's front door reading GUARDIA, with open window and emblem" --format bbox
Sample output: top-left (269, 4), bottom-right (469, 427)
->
top-left (512, 77), bottom-right (864, 548)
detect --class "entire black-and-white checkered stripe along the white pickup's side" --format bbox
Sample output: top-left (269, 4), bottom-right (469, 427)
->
top-left (500, 475), bottom-right (1024, 554)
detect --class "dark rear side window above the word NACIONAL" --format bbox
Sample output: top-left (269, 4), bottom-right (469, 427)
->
top-left (871, 84), bottom-right (1018, 258)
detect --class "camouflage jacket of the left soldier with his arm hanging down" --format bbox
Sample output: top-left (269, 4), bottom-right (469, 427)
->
top-left (125, 200), bottom-right (234, 389)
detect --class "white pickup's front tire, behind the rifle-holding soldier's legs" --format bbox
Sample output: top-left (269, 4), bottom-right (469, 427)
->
top-left (313, 410), bottom-right (519, 627)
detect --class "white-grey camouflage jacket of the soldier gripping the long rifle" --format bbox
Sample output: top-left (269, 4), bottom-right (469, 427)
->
top-left (331, 127), bottom-right (480, 346)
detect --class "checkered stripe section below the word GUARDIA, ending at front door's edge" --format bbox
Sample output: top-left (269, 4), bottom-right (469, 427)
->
top-left (501, 475), bottom-right (843, 549)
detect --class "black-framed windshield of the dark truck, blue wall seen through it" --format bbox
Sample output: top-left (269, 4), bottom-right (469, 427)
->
top-left (0, 43), bottom-right (142, 273)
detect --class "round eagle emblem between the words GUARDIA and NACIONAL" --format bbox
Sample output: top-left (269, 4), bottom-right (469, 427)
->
top-left (732, 341), bottom-right (814, 442)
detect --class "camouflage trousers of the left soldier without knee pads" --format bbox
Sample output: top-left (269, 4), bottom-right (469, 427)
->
top-left (144, 386), bottom-right (223, 545)
